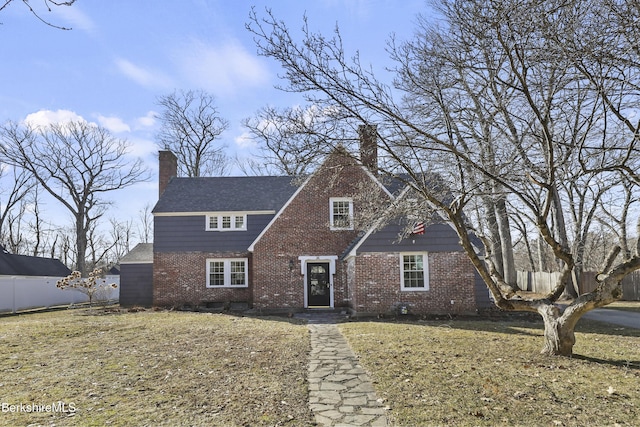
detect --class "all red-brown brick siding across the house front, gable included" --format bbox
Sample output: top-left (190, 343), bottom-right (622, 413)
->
top-left (153, 147), bottom-right (476, 315)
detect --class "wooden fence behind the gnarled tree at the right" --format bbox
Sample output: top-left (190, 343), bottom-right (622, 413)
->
top-left (518, 271), bottom-right (640, 301)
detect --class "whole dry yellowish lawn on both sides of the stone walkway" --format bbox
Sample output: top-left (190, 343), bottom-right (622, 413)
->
top-left (0, 309), bottom-right (640, 426)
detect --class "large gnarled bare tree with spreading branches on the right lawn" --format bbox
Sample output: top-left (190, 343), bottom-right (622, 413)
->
top-left (248, 0), bottom-right (640, 355)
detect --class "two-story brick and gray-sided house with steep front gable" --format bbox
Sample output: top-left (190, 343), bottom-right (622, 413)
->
top-left (121, 126), bottom-right (489, 315)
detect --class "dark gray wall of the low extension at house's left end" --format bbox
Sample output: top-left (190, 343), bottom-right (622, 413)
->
top-left (120, 263), bottom-right (153, 307)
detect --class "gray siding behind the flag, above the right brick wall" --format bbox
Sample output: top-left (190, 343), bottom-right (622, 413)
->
top-left (358, 223), bottom-right (462, 253)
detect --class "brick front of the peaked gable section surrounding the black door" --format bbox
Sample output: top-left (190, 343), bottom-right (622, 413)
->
top-left (253, 154), bottom-right (382, 309)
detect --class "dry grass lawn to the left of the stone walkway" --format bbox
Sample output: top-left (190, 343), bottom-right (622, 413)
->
top-left (0, 309), bottom-right (311, 426)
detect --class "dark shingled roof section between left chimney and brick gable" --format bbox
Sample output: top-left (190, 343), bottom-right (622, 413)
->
top-left (153, 176), bottom-right (297, 214)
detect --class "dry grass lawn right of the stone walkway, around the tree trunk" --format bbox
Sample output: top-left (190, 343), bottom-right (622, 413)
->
top-left (340, 320), bottom-right (640, 426)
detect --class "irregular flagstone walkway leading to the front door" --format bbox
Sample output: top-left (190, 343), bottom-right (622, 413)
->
top-left (309, 321), bottom-right (388, 426)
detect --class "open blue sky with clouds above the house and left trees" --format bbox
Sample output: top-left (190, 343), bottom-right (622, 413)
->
top-left (0, 0), bottom-right (428, 237)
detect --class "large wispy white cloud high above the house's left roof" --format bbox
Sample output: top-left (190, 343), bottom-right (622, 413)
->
top-left (177, 40), bottom-right (270, 95)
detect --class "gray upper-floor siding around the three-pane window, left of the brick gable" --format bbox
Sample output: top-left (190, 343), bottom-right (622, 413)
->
top-left (153, 214), bottom-right (273, 252)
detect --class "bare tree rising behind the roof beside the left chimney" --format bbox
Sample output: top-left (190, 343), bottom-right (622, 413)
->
top-left (158, 90), bottom-right (230, 177)
